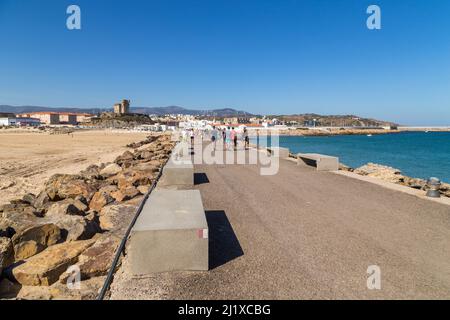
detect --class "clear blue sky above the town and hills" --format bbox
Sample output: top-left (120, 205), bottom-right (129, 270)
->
top-left (0, 0), bottom-right (450, 125)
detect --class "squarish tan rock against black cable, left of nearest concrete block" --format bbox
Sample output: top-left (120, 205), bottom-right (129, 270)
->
top-left (99, 204), bottom-right (136, 232)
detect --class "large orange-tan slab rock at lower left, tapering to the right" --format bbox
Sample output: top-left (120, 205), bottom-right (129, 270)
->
top-left (9, 240), bottom-right (94, 286)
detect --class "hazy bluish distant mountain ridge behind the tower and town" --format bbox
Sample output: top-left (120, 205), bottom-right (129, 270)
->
top-left (0, 105), bottom-right (252, 117)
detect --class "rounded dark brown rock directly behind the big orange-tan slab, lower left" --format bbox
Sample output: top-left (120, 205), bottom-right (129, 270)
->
top-left (12, 223), bottom-right (61, 261)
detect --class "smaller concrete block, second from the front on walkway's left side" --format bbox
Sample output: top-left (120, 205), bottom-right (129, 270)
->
top-left (159, 154), bottom-right (194, 186)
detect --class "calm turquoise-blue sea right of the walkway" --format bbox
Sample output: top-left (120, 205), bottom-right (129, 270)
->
top-left (252, 131), bottom-right (450, 183)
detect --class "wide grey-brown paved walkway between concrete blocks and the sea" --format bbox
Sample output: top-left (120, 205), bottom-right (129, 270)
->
top-left (113, 148), bottom-right (450, 299)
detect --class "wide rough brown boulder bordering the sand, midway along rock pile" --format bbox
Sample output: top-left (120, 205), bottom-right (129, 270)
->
top-left (45, 174), bottom-right (97, 201)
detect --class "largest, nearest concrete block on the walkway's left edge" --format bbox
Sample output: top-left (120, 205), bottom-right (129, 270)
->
top-left (129, 190), bottom-right (209, 275)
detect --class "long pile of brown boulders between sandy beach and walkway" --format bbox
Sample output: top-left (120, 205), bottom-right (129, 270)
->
top-left (0, 135), bottom-right (174, 299)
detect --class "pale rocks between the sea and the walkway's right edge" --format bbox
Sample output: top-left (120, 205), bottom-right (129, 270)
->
top-left (340, 163), bottom-right (450, 197)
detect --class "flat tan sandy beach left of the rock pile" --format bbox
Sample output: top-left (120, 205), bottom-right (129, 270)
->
top-left (0, 130), bottom-right (149, 205)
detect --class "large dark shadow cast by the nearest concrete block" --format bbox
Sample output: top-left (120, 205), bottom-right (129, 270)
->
top-left (205, 211), bottom-right (244, 270)
